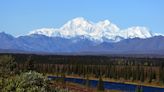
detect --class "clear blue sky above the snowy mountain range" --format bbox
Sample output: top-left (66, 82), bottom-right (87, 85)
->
top-left (0, 0), bottom-right (164, 36)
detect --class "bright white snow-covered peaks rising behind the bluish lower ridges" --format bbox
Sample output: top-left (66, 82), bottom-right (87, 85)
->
top-left (29, 17), bottom-right (154, 42)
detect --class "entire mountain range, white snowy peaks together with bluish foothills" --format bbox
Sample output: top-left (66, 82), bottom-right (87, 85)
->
top-left (0, 17), bottom-right (164, 54)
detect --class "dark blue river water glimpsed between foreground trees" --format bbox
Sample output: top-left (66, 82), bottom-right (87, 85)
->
top-left (48, 76), bottom-right (164, 92)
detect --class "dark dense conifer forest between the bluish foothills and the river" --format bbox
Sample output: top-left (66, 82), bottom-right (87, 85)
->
top-left (1, 54), bottom-right (164, 85)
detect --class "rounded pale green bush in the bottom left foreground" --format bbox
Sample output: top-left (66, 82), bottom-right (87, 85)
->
top-left (3, 71), bottom-right (49, 92)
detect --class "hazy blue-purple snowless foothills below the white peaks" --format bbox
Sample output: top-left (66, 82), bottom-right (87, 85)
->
top-left (0, 33), bottom-right (164, 55)
